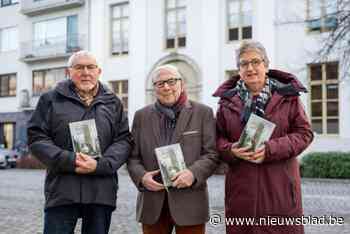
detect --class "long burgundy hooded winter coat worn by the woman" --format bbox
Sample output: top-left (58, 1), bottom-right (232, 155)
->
top-left (214, 70), bottom-right (313, 234)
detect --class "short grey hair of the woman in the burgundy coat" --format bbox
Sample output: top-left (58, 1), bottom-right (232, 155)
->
top-left (236, 40), bottom-right (270, 69)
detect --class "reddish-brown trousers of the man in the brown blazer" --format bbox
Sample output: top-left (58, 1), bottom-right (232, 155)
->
top-left (142, 201), bottom-right (205, 234)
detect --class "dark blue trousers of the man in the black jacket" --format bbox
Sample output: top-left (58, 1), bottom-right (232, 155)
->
top-left (44, 204), bottom-right (114, 234)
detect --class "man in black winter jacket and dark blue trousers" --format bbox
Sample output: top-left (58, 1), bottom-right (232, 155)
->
top-left (28, 51), bottom-right (131, 234)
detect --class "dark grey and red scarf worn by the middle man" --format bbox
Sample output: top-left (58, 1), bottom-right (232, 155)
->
top-left (155, 91), bottom-right (187, 145)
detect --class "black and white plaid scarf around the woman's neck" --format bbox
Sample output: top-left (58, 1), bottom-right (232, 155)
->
top-left (235, 77), bottom-right (277, 123)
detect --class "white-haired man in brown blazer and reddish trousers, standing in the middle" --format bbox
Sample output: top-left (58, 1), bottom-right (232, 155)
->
top-left (128, 64), bottom-right (218, 234)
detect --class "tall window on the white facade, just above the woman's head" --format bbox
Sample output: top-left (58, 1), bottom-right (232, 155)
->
top-left (227, 0), bottom-right (252, 41)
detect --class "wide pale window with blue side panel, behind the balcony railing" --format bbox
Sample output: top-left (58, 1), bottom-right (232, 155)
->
top-left (33, 15), bottom-right (79, 55)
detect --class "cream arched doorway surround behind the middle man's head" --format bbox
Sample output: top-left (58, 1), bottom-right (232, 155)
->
top-left (146, 54), bottom-right (202, 104)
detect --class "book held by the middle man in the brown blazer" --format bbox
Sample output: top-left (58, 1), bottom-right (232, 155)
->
top-left (155, 143), bottom-right (186, 189)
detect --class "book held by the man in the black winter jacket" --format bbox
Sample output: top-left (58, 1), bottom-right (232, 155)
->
top-left (69, 119), bottom-right (102, 158)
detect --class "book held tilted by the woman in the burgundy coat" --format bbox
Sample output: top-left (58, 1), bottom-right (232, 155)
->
top-left (238, 113), bottom-right (276, 151)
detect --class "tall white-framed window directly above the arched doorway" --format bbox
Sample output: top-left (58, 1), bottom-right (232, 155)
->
top-left (165, 0), bottom-right (186, 49)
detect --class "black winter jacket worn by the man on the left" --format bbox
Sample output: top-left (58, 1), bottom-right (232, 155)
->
top-left (28, 80), bottom-right (132, 208)
